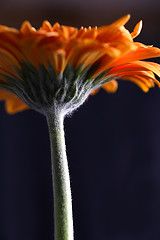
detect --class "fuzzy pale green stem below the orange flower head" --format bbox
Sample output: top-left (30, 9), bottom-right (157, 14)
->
top-left (46, 110), bottom-right (73, 240)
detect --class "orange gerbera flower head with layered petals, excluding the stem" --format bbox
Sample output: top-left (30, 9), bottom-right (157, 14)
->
top-left (0, 15), bottom-right (160, 113)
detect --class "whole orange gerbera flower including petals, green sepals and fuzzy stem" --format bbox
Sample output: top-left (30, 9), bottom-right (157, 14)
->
top-left (0, 15), bottom-right (160, 240)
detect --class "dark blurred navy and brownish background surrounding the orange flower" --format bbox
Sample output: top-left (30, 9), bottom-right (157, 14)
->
top-left (0, 0), bottom-right (160, 240)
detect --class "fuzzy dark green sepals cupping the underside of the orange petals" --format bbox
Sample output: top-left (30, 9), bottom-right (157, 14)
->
top-left (0, 61), bottom-right (113, 114)
